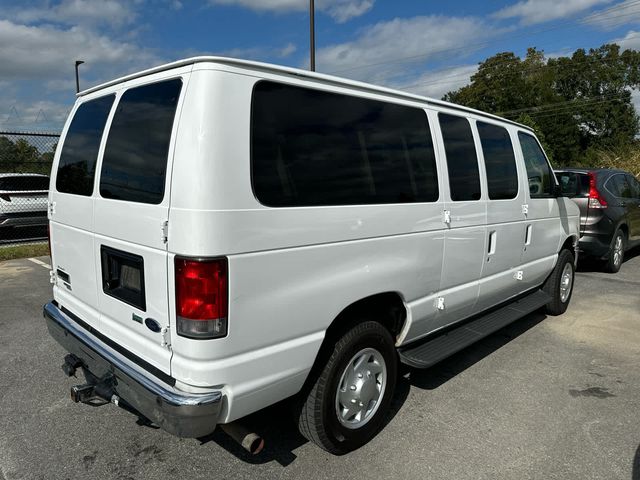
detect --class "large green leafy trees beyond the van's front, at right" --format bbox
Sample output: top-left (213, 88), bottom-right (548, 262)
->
top-left (444, 45), bottom-right (640, 165)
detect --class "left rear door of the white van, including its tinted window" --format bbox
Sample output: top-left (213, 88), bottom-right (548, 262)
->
top-left (48, 94), bottom-right (115, 330)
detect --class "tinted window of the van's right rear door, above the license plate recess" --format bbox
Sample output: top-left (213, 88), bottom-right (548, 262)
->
top-left (100, 80), bottom-right (182, 204)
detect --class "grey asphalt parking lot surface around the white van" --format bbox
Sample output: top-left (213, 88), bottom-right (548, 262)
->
top-left (0, 251), bottom-right (640, 480)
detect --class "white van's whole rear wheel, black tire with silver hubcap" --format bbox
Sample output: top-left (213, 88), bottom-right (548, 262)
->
top-left (295, 321), bottom-right (398, 455)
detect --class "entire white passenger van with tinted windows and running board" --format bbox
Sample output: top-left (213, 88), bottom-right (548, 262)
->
top-left (44, 57), bottom-right (579, 453)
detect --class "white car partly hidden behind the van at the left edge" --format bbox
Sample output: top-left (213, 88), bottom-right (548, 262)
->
top-left (0, 173), bottom-right (49, 239)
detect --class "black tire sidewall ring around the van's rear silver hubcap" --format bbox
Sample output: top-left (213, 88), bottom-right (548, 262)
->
top-left (322, 322), bottom-right (398, 452)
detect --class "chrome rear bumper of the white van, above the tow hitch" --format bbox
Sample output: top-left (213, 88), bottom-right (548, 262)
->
top-left (43, 302), bottom-right (223, 438)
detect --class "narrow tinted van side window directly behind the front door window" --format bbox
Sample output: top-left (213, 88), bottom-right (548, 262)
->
top-left (477, 122), bottom-right (518, 200)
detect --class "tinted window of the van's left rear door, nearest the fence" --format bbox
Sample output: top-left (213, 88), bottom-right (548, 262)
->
top-left (56, 95), bottom-right (115, 196)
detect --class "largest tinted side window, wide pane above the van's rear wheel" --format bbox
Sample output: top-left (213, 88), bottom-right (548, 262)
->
top-left (251, 82), bottom-right (438, 207)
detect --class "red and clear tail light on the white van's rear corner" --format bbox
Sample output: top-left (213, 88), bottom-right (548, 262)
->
top-left (175, 257), bottom-right (228, 339)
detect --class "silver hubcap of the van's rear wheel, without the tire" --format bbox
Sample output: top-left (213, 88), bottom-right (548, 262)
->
top-left (335, 348), bottom-right (387, 429)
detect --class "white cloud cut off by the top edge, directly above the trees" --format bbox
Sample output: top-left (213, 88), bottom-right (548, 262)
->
top-left (493, 0), bottom-right (612, 25)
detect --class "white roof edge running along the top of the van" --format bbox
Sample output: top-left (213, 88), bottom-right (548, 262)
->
top-left (77, 56), bottom-right (533, 130)
